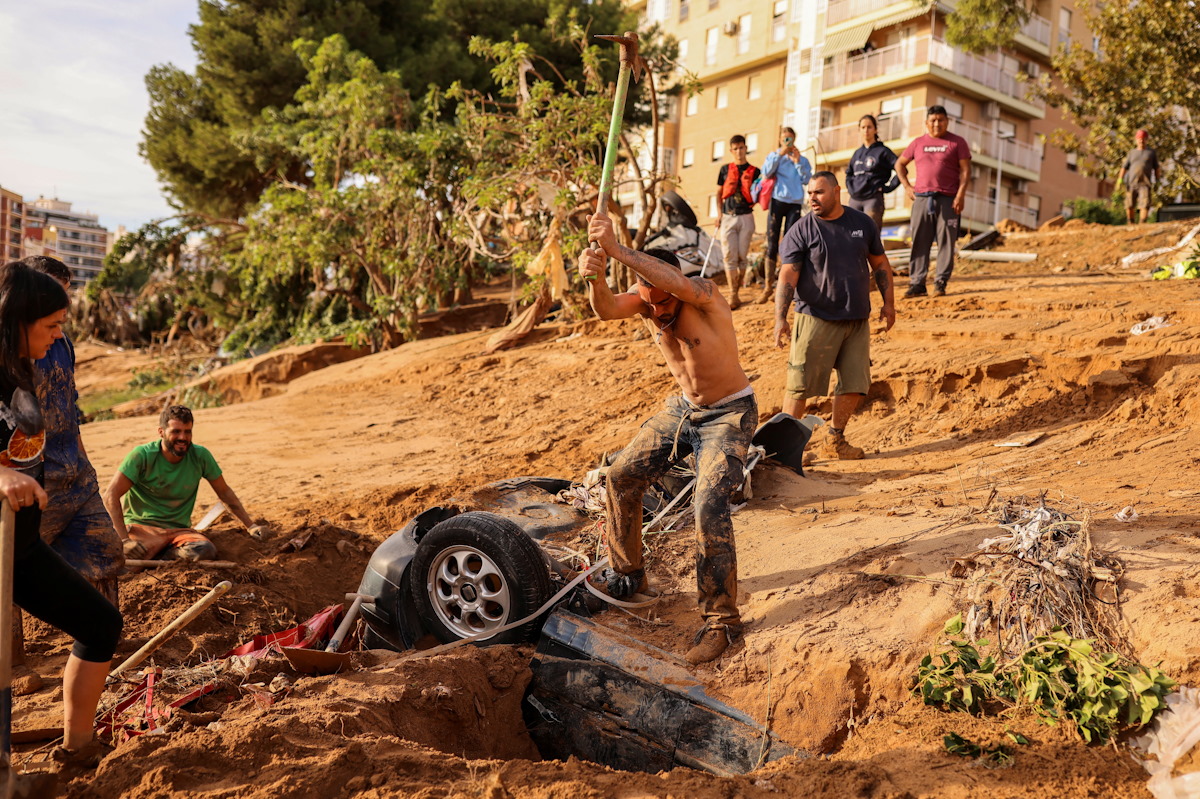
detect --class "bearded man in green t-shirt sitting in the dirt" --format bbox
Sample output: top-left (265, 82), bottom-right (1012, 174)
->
top-left (104, 405), bottom-right (266, 560)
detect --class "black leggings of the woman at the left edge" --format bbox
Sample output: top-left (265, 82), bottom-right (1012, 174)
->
top-left (12, 537), bottom-right (125, 663)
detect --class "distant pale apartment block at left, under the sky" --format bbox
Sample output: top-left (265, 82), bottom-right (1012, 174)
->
top-left (24, 197), bottom-right (108, 286)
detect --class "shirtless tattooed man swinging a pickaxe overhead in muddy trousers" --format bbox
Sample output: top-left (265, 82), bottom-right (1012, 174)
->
top-left (578, 214), bottom-right (758, 665)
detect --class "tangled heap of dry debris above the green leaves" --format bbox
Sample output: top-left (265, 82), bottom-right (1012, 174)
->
top-left (950, 498), bottom-right (1133, 657)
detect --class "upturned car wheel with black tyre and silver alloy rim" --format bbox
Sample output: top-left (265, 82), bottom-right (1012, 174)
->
top-left (410, 511), bottom-right (552, 644)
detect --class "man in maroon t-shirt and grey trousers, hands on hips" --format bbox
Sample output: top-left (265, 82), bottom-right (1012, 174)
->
top-left (896, 106), bottom-right (971, 298)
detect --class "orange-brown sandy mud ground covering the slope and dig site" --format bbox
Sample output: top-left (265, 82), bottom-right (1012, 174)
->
top-left (9, 219), bottom-right (1200, 799)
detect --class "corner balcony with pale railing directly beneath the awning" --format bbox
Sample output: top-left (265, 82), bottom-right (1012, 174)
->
top-left (821, 36), bottom-right (1045, 116)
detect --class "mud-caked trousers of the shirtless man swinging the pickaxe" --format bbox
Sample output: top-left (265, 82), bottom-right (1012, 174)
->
top-left (607, 395), bottom-right (758, 629)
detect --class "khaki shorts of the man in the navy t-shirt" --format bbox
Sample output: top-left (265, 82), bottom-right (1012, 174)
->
top-left (785, 313), bottom-right (871, 400)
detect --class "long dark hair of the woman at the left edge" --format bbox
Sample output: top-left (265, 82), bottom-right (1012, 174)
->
top-left (0, 260), bottom-right (70, 391)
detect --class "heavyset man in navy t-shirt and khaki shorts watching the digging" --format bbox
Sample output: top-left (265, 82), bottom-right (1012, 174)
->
top-left (775, 172), bottom-right (896, 461)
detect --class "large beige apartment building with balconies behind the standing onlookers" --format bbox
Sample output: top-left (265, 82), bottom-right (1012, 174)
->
top-left (643, 0), bottom-right (1111, 233)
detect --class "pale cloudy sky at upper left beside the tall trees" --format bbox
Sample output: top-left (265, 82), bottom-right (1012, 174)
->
top-left (0, 0), bottom-right (197, 230)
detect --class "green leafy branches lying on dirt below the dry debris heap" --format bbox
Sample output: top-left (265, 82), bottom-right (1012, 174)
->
top-left (913, 614), bottom-right (1175, 743)
